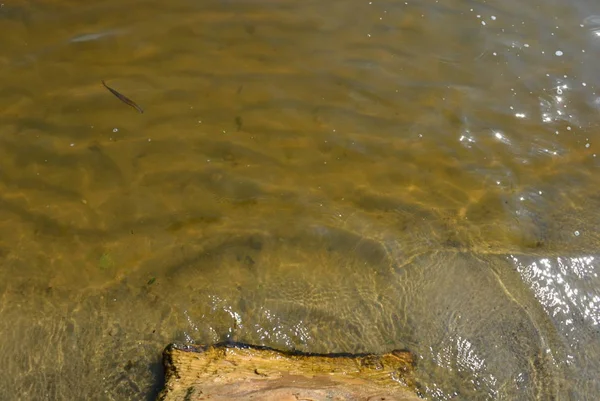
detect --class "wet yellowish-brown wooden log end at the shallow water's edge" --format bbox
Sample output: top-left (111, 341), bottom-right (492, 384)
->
top-left (158, 343), bottom-right (420, 401)
